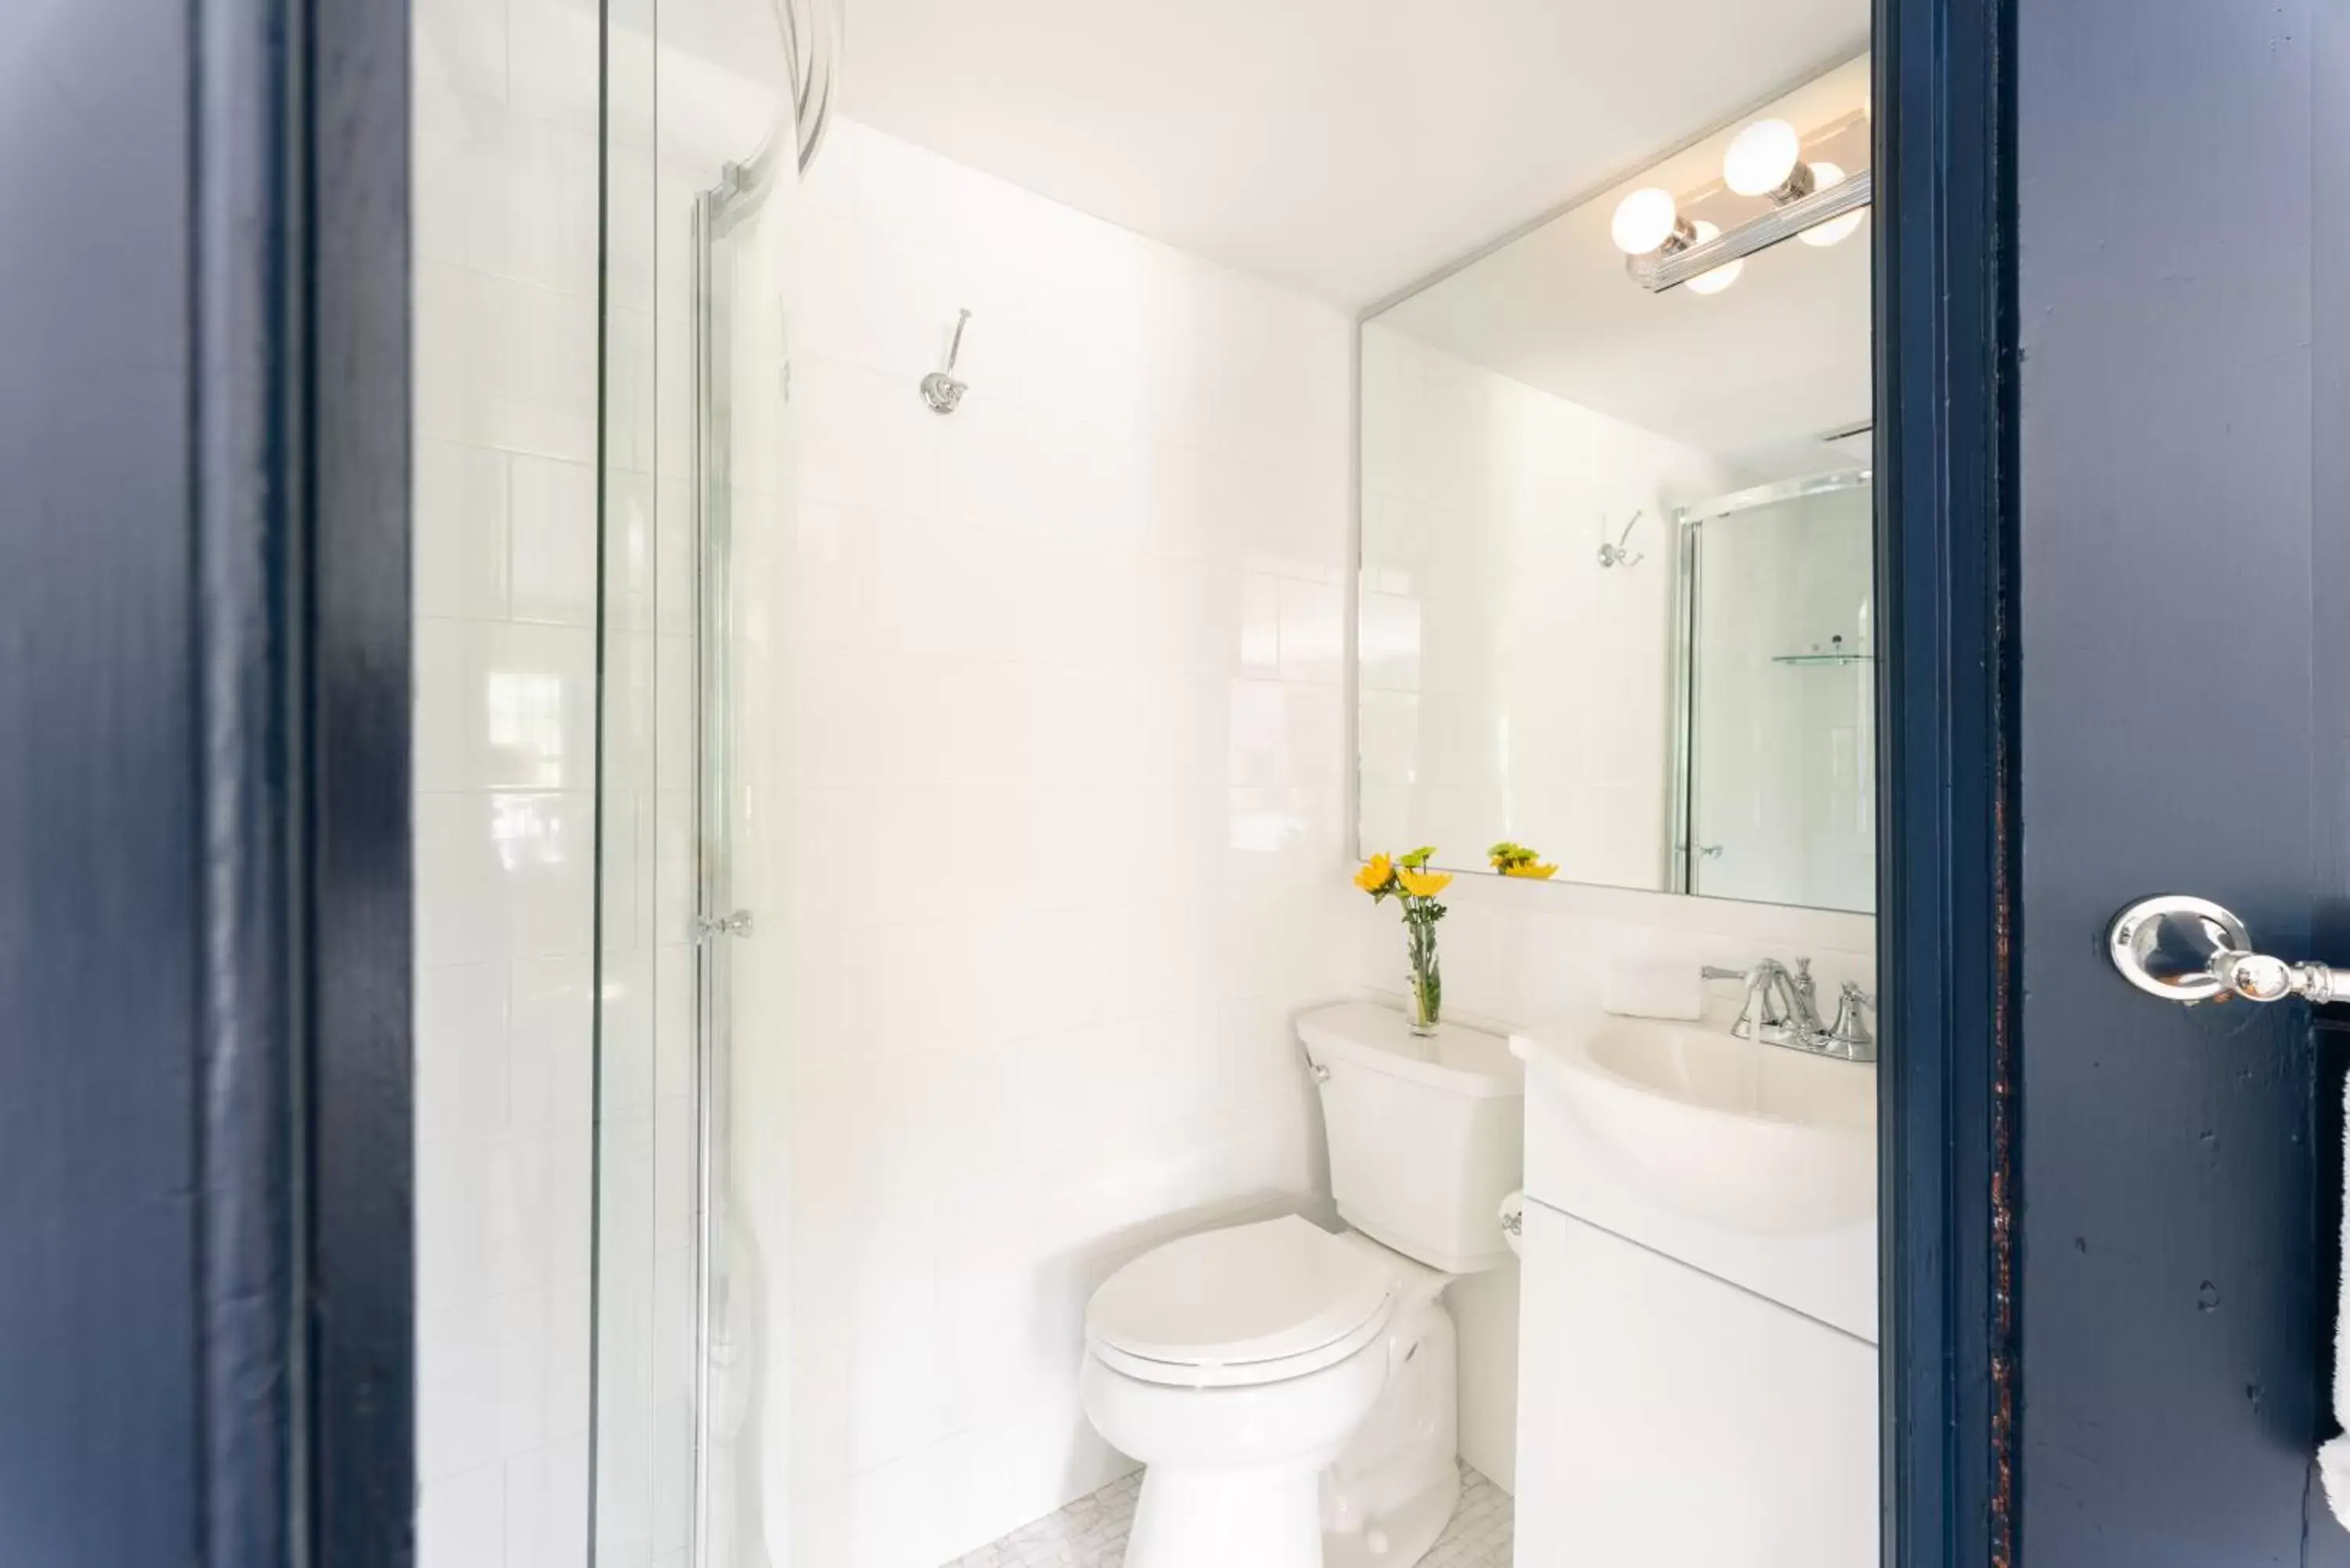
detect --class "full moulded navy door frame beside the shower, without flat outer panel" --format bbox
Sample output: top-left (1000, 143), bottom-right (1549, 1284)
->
top-left (190, 0), bottom-right (416, 1568)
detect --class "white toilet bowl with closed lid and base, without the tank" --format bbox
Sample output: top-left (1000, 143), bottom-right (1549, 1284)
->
top-left (1079, 1216), bottom-right (1459, 1568)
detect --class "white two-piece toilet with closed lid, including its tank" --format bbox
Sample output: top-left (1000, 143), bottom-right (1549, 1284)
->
top-left (1079, 1002), bottom-right (1525, 1568)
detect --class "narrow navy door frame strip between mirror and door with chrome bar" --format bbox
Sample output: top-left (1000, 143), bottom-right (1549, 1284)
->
top-left (1873, 0), bottom-right (2021, 1568)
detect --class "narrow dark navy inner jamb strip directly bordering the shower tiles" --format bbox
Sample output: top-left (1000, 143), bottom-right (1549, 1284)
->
top-left (301, 0), bottom-right (416, 1568)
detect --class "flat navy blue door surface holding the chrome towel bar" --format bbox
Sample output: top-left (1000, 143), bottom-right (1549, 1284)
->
top-left (2012, 0), bottom-right (2350, 1568)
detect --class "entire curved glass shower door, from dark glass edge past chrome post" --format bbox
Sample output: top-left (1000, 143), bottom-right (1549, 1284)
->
top-left (597, 0), bottom-right (837, 1568)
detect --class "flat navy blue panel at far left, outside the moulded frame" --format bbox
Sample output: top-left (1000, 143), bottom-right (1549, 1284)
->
top-left (0, 2), bottom-right (202, 1568)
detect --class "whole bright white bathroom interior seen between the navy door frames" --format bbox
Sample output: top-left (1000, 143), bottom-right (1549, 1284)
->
top-left (414, 0), bottom-right (1871, 1568)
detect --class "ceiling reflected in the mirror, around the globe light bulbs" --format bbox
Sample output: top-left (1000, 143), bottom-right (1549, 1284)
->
top-left (1379, 56), bottom-right (1871, 479)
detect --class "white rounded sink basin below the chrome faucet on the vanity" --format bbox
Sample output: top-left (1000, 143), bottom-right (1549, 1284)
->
top-left (1509, 1013), bottom-right (1878, 1234)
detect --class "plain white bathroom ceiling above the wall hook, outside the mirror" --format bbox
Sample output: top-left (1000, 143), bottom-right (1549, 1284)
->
top-left (841, 0), bottom-right (1868, 308)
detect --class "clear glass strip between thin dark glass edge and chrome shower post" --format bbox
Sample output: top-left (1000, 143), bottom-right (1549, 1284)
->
top-left (592, 0), bottom-right (693, 1568)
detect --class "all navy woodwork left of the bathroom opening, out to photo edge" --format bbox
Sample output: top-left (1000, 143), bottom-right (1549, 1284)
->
top-left (0, 0), bottom-right (416, 1568)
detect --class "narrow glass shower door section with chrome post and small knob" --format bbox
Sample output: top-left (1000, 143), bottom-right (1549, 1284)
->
top-left (693, 156), bottom-right (797, 1568)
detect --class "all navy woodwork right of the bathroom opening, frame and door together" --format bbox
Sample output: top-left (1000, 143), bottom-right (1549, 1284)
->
top-left (1878, 0), bottom-right (2350, 1568)
